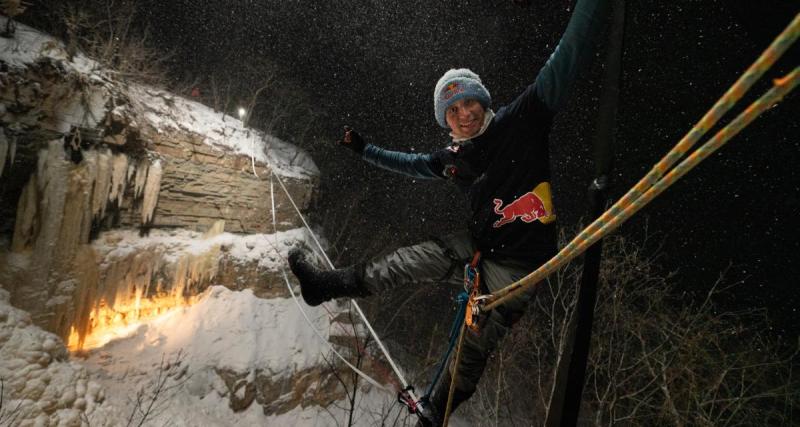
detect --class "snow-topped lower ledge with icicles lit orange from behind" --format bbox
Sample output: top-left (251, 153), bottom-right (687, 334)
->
top-left (68, 226), bottom-right (306, 350)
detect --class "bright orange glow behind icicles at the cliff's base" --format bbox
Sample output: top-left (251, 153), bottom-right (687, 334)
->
top-left (67, 295), bottom-right (198, 351)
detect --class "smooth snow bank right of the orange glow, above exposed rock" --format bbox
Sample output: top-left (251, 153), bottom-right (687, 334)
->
top-left (89, 286), bottom-right (328, 376)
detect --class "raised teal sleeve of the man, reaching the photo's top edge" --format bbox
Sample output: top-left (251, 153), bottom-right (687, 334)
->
top-left (533, 0), bottom-right (610, 112)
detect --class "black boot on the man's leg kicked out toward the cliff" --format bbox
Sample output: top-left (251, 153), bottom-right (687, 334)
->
top-left (289, 248), bottom-right (371, 306)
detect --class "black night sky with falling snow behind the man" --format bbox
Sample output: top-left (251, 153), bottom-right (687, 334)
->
top-left (134, 0), bottom-right (800, 336)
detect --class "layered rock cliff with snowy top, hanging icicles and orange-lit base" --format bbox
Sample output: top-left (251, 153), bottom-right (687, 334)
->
top-left (0, 16), bottom-right (384, 424)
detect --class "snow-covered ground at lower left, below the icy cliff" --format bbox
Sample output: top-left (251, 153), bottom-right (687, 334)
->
top-left (0, 287), bottom-right (410, 427)
